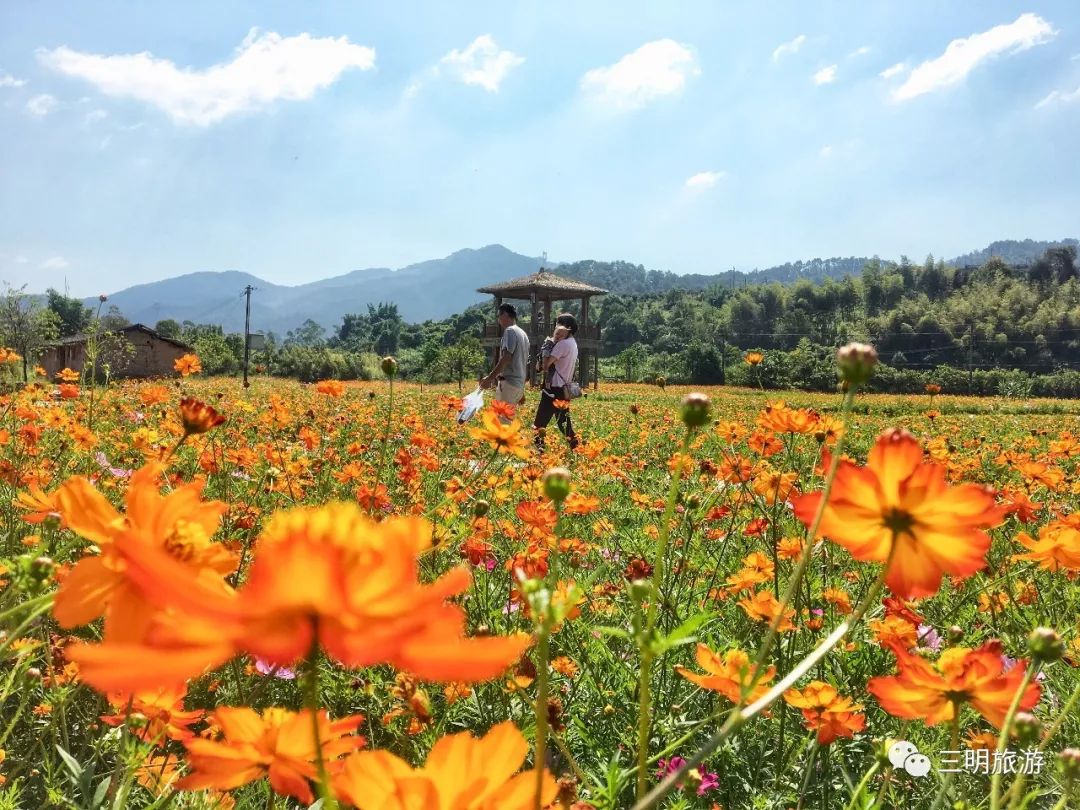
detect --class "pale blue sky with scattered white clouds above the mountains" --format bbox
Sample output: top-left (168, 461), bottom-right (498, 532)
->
top-left (0, 0), bottom-right (1080, 295)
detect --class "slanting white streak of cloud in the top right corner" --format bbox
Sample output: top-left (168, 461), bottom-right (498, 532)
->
top-left (892, 13), bottom-right (1057, 102)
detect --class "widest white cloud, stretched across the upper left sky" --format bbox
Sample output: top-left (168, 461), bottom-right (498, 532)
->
top-left (38, 28), bottom-right (375, 126)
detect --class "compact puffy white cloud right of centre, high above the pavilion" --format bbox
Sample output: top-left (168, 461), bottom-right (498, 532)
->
top-left (581, 39), bottom-right (701, 110)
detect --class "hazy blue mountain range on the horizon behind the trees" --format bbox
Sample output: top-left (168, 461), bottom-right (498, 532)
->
top-left (78, 239), bottom-right (1077, 334)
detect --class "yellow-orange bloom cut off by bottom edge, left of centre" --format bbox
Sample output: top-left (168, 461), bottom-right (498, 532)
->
top-left (334, 723), bottom-right (558, 810)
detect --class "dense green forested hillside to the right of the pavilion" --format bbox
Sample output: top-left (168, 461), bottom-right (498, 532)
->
top-left (596, 245), bottom-right (1080, 388)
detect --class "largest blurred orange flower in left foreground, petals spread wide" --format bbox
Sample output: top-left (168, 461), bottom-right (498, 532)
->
top-left (68, 502), bottom-right (529, 690)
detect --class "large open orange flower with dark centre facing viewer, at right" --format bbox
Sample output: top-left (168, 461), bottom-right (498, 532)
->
top-left (792, 429), bottom-right (1003, 597)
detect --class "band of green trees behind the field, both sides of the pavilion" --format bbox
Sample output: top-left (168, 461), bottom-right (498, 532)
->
top-left (19, 245), bottom-right (1080, 395)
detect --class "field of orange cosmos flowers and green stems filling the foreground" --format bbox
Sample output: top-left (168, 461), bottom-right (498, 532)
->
top-left (0, 354), bottom-right (1080, 810)
